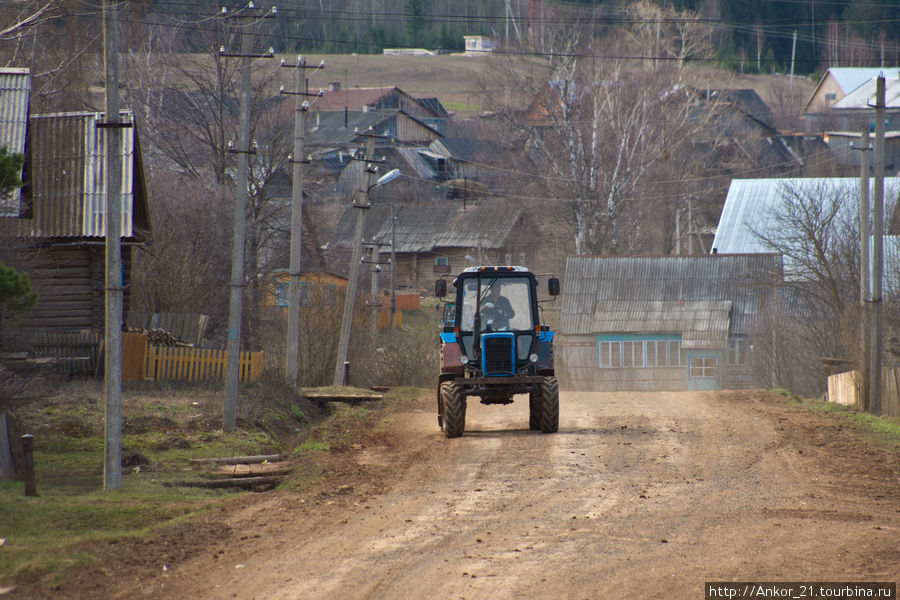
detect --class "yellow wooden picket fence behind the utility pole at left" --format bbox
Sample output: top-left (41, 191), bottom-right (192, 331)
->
top-left (144, 346), bottom-right (263, 381)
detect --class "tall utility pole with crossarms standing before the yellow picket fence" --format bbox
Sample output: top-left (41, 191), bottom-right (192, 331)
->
top-left (219, 2), bottom-right (275, 433)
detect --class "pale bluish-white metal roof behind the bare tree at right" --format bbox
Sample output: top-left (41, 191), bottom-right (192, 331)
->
top-left (712, 177), bottom-right (900, 255)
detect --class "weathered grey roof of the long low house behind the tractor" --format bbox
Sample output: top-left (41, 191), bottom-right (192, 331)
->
top-left (328, 202), bottom-right (524, 253)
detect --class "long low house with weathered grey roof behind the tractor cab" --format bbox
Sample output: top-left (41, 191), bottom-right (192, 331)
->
top-left (326, 201), bottom-right (538, 289)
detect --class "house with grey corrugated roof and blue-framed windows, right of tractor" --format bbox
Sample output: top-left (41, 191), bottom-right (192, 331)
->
top-left (559, 254), bottom-right (781, 391)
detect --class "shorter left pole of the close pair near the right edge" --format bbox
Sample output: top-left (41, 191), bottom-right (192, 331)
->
top-left (858, 125), bottom-right (872, 410)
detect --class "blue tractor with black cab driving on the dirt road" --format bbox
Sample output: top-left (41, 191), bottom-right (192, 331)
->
top-left (435, 266), bottom-right (559, 438)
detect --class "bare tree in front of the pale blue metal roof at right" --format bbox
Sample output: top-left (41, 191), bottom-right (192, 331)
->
top-left (752, 179), bottom-right (900, 394)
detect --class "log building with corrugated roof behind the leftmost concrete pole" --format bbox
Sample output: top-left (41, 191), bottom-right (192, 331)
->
top-left (0, 107), bottom-right (151, 331)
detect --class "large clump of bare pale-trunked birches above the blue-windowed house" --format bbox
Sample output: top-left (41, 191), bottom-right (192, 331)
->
top-left (484, 12), bottom-right (715, 254)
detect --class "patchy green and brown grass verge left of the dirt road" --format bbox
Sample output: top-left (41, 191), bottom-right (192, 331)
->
top-left (0, 382), bottom-right (418, 596)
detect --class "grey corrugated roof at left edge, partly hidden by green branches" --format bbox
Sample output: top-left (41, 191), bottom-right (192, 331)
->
top-left (0, 68), bottom-right (31, 217)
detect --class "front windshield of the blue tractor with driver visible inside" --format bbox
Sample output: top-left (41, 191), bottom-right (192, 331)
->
top-left (460, 277), bottom-right (534, 331)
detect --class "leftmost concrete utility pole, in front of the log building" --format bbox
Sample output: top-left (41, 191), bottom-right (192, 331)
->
top-left (101, 0), bottom-right (122, 490)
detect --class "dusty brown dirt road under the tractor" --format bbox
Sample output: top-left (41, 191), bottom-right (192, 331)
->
top-left (103, 392), bottom-right (900, 600)
